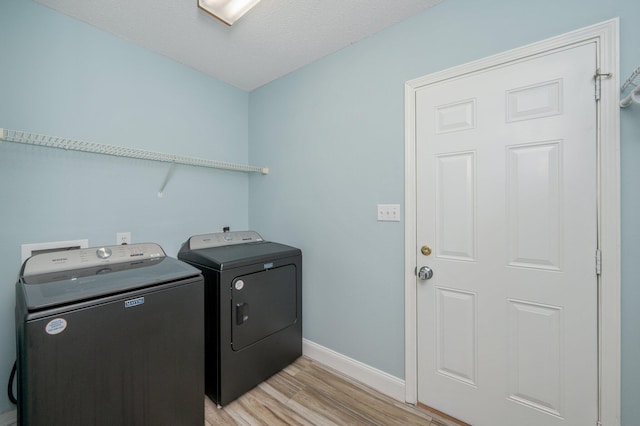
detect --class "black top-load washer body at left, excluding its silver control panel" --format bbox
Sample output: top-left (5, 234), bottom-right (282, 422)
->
top-left (16, 245), bottom-right (204, 426)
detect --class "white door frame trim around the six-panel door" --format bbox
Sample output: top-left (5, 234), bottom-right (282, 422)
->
top-left (404, 18), bottom-right (620, 426)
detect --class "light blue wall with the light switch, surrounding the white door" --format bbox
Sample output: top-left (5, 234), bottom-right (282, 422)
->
top-left (249, 0), bottom-right (640, 425)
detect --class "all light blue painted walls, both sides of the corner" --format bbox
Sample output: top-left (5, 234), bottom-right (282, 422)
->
top-left (0, 0), bottom-right (640, 425)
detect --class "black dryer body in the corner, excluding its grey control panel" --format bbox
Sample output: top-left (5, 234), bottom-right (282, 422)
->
top-left (178, 233), bottom-right (302, 406)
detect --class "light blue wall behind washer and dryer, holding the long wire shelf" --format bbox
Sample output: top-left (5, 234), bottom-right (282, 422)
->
top-left (0, 0), bottom-right (249, 412)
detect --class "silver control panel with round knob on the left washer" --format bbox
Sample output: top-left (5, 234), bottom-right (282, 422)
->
top-left (22, 243), bottom-right (166, 276)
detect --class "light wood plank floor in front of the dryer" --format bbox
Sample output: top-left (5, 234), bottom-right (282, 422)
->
top-left (205, 357), bottom-right (460, 426)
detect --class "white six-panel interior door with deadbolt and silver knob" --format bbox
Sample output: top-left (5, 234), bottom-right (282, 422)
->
top-left (415, 43), bottom-right (598, 426)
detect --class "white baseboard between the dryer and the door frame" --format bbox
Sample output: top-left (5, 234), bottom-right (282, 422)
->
top-left (302, 339), bottom-right (405, 402)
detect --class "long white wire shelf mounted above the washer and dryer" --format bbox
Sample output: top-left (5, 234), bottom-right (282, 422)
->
top-left (0, 128), bottom-right (269, 175)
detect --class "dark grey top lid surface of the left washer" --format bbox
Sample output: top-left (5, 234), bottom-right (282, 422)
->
top-left (17, 246), bottom-right (200, 311)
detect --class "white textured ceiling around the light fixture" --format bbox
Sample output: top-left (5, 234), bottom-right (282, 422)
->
top-left (35, 0), bottom-right (441, 91)
